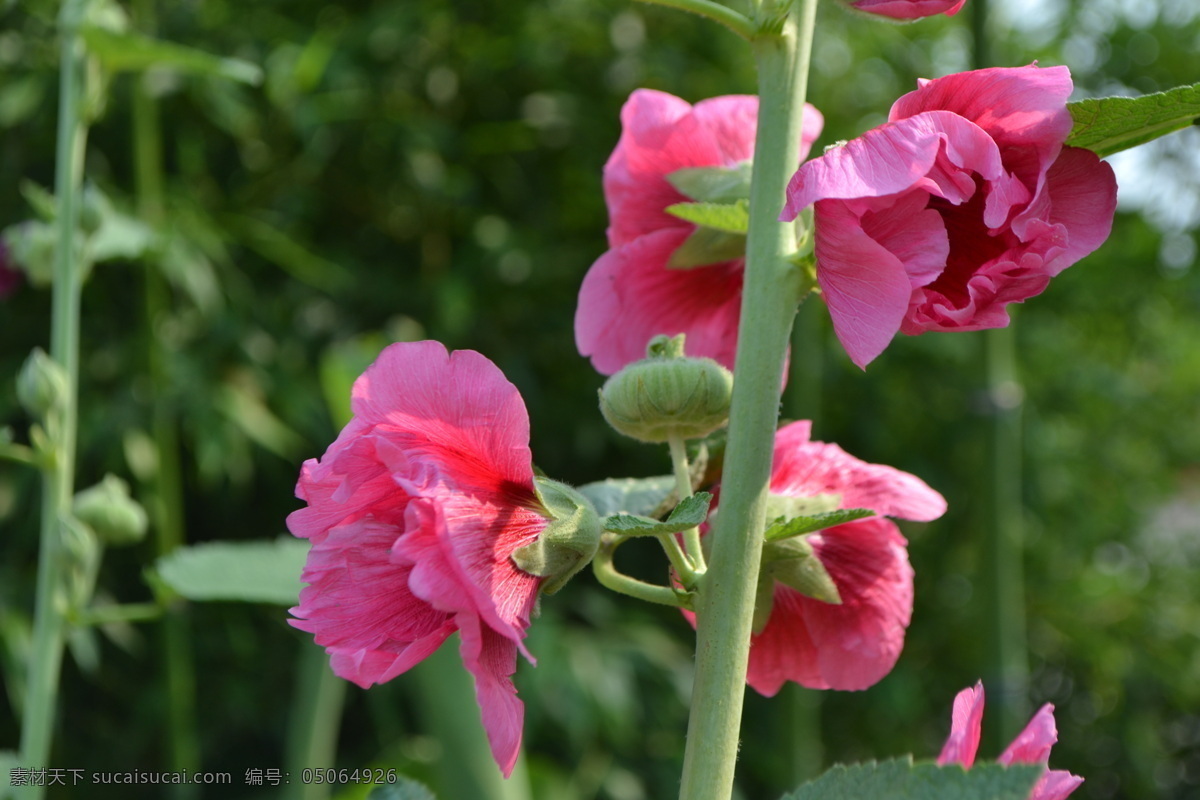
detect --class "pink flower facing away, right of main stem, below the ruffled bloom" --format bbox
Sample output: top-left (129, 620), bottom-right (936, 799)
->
top-left (689, 421), bottom-right (946, 697)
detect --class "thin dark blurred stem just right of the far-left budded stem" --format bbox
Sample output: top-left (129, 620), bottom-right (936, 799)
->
top-left (132, 0), bottom-right (200, 786)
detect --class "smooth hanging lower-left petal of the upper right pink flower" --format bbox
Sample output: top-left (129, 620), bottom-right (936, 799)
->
top-left (815, 200), bottom-right (921, 368)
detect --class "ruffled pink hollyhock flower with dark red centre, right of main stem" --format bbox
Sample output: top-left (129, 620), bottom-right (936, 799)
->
top-left (782, 65), bottom-right (1116, 367)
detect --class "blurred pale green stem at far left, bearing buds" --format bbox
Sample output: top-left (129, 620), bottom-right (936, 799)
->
top-left (20, 0), bottom-right (86, 800)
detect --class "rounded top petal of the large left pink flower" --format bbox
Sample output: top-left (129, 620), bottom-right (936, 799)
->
top-left (352, 342), bottom-right (533, 494)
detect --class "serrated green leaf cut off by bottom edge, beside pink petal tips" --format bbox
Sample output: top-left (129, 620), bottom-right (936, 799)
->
top-left (782, 757), bottom-right (1045, 800)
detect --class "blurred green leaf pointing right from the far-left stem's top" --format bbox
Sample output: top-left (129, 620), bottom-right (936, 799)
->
top-left (80, 25), bottom-right (263, 85)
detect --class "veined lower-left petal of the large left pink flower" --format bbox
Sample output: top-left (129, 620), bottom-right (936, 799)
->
top-left (288, 518), bottom-right (455, 688)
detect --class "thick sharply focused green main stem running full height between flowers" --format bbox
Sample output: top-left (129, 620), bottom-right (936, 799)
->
top-left (679, 0), bottom-right (816, 800)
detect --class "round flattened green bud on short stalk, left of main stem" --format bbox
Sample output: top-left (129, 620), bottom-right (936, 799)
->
top-left (600, 333), bottom-right (733, 441)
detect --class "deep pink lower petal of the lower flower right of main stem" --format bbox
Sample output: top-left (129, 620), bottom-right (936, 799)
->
top-left (746, 518), bottom-right (913, 697)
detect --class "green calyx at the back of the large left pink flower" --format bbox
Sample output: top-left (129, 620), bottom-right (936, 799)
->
top-left (512, 476), bottom-right (601, 595)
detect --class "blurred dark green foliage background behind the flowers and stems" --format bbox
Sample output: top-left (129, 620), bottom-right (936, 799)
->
top-left (0, 0), bottom-right (1200, 800)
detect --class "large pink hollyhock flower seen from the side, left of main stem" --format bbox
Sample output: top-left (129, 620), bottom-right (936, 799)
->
top-left (288, 342), bottom-right (548, 775)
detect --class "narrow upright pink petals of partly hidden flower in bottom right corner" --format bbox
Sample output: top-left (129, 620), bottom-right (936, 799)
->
top-left (937, 682), bottom-right (1084, 800)
